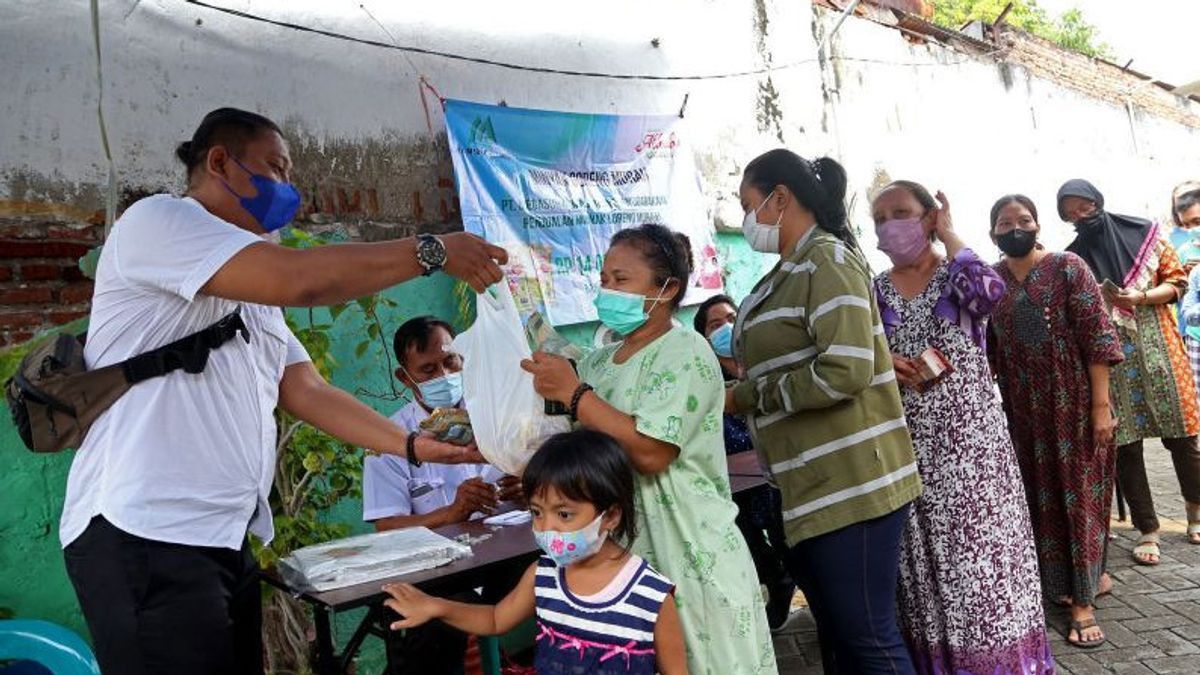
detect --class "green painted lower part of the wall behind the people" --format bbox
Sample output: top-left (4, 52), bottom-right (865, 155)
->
top-left (0, 234), bottom-right (773, 665)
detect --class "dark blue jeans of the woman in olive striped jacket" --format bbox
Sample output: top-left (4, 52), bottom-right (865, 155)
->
top-left (787, 506), bottom-right (916, 675)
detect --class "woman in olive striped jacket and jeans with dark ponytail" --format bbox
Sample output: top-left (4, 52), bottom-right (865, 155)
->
top-left (726, 150), bottom-right (922, 675)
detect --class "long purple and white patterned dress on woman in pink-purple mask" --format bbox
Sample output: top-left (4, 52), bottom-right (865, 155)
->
top-left (875, 250), bottom-right (1055, 675)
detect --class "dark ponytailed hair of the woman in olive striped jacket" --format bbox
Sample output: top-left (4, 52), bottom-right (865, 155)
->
top-left (743, 148), bottom-right (858, 249)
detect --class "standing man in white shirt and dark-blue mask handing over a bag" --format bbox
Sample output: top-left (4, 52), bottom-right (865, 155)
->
top-left (60, 108), bottom-right (505, 675)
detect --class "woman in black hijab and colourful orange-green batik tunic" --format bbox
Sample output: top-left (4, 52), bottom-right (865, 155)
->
top-left (1058, 180), bottom-right (1200, 565)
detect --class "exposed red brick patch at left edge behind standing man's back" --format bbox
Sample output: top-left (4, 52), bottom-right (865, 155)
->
top-left (0, 219), bottom-right (103, 348)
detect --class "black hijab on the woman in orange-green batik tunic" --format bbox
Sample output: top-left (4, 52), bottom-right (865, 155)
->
top-left (1058, 179), bottom-right (1154, 287)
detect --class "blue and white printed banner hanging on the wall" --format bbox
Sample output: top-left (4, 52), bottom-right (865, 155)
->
top-left (445, 101), bottom-right (721, 325)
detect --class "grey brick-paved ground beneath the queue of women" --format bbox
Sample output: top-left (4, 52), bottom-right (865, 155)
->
top-left (775, 442), bottom-right (1200, 675)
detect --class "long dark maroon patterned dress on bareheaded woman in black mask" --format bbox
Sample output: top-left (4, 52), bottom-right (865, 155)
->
top-left (990, 253), bottom-right (1122, 605)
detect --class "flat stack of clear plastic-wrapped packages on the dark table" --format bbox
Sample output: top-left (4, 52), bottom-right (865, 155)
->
top-left (280, 527), bottom-right (472, 592)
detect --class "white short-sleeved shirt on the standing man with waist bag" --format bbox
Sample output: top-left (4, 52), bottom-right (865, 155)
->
top-left (59, 195), bottom-right (308, 550)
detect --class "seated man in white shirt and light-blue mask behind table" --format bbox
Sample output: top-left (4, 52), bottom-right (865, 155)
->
top-left (362, 316), bottom-right (523, 675)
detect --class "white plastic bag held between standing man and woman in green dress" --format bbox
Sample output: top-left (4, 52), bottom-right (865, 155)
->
top-left (454, 282), bottom-right (571, 476)
